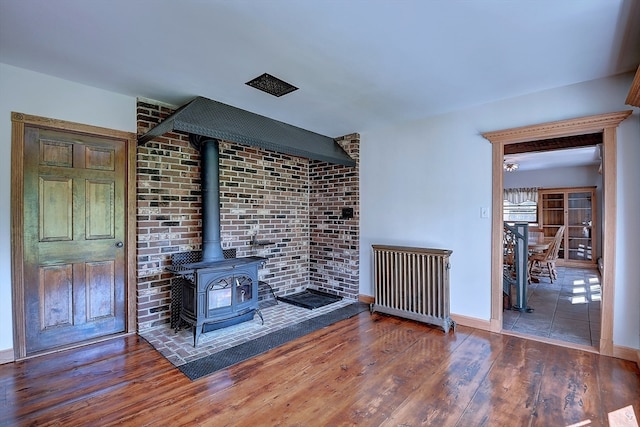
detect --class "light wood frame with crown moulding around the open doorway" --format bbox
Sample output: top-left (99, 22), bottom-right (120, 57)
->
top-left (482, 110), bottom-right (633, 356)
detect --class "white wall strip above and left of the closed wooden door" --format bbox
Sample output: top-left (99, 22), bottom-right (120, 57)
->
top-left (0, 63), bottom-right (136, 351)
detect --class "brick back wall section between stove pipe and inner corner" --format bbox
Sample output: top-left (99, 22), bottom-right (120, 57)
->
top-left (220, 142), bottom-right (309, 295)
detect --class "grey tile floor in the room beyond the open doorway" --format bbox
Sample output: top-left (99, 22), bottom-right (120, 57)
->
top-left (502, 267), bottom-right (600, 347)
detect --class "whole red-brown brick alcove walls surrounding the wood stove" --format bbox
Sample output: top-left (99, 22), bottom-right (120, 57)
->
top-left (136, 100), bottom-right (360, 331)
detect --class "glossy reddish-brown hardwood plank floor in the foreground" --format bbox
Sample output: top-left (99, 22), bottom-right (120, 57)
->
top-left (0, 312), bottom-right (640, 426)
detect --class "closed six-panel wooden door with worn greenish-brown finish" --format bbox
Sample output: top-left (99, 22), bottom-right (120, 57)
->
top-left (23, 126), bottom-right (127, 355)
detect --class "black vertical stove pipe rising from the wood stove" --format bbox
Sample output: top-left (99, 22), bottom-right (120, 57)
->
top-left (191, 137), bottom-right (224, 261)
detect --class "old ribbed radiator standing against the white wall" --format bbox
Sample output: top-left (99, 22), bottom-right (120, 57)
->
top-left (371, 245), bottom-right (456, 333)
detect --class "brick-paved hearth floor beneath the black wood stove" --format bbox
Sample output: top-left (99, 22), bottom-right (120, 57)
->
top-left (139, 298), bottom-right (356, 366)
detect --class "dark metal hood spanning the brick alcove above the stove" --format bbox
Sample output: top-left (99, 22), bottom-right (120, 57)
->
top-left (138, 97), bottom-right (356, 166)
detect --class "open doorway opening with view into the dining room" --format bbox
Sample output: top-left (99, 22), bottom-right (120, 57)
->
top-left (502, 136), bottom-right (603, 349)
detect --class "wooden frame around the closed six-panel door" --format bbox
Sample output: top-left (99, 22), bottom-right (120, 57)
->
top-left (11, 112), bottom-right (137, 360)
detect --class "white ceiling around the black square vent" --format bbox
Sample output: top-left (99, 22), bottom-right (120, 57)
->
top-left (0, 0), bottom-right (640, 137)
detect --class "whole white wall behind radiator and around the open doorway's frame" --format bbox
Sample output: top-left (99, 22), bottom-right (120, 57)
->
top-left (360, 74), bottom-right (640, 348)
